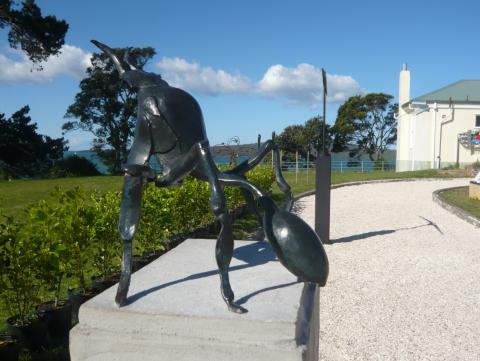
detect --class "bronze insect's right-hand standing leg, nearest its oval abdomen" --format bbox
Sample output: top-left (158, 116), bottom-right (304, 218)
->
top-left (196, 143), bottom-right (247, 313)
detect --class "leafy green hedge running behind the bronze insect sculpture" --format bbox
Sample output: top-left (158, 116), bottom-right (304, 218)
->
top-left (0, 168), bottom-right (274, 319)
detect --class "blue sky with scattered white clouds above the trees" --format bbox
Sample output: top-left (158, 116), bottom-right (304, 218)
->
top-left (0, 0), bottom-right (480, 150)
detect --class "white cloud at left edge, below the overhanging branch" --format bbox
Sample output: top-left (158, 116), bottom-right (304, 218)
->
top-left (0, 45), bottom-right (91, 84)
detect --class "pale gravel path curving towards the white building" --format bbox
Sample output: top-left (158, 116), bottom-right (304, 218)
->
top-left (297, 179), bottom-right (480, 361)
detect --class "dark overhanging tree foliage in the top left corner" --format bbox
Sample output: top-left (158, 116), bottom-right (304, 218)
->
top-left (0, 0), bottom-right (68, 64)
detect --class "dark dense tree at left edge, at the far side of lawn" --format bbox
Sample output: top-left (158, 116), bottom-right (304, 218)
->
top-left (0, 105), bottom-right (66, 177)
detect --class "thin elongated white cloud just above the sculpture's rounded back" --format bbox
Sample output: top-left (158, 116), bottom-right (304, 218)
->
top-left (156, 57), bottom-right (251, 95)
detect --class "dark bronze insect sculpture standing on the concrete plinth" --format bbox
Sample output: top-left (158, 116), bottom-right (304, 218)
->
top-left (92, 40), bottom-right (328, 313)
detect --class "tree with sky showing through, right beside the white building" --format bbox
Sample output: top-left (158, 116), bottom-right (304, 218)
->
top-left (333, 93), bottom-right (398, 161)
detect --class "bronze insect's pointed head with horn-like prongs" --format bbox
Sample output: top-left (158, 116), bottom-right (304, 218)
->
top-left (92, 40), bottom-right (168, 88)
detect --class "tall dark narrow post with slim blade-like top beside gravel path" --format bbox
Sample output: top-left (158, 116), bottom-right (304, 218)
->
top-left (315, 68), bottom-right (332, 243)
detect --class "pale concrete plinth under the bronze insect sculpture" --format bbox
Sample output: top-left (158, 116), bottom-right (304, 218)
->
top-left (70, 239), bottom-right (319, 361)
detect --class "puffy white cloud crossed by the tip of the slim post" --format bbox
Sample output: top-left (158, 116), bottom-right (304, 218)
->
top-left (257, 64), bottom-right (363, 107)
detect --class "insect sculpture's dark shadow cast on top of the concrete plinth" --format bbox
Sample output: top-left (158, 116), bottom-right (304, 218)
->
top-left (126, 242), bottom-right (280, 305)
